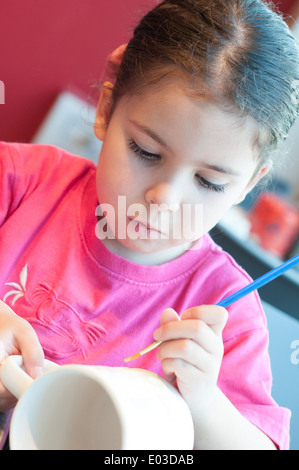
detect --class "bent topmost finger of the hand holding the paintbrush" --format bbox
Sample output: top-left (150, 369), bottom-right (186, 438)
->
top-left (181, 305), bottom-right (228, 335)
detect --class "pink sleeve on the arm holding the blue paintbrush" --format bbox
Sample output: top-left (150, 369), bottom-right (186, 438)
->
top-left (219, 310), bottom-right (291, 450)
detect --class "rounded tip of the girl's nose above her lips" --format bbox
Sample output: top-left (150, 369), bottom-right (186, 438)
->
top-left (145, 183), bottom-right (181, 212)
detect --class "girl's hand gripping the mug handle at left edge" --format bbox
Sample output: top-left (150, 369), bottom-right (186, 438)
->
top-left (0, 301), bottom-right (44, 412)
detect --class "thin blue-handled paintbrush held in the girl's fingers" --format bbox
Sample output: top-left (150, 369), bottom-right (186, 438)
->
top-left (125, 255), bottom-right (299, 362)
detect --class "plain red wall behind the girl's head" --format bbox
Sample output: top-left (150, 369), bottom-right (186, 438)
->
top-left (0, 0), bottom-right (294, 142)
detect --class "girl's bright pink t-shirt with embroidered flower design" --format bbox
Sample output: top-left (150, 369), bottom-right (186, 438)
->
top-left (0, 143), bottom-right (290, 449)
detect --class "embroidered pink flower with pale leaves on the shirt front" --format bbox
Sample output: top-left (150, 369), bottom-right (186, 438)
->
top-left (3, 264), bottom-right (107, 361)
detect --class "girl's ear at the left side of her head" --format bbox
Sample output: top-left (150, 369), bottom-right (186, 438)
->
top-left (94, 82), bottom-right (113, 142)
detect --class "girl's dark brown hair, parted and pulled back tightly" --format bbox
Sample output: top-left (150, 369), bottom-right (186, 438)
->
top-left (105, 0), bottom-right (299, 160)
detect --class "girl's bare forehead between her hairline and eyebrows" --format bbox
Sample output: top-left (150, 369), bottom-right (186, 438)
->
top-left (123, 82), bottom-right (257, 147)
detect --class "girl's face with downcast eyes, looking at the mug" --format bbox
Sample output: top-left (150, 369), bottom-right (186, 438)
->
top-left (95, 81), bottom-right (266, 264)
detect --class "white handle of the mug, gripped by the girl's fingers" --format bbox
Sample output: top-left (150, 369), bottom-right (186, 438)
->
top-left (0, 356), bottom-right (59, 400)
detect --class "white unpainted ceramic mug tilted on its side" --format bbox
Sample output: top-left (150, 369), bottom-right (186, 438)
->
top-left (0, 356), bottom-right (194, 450)
